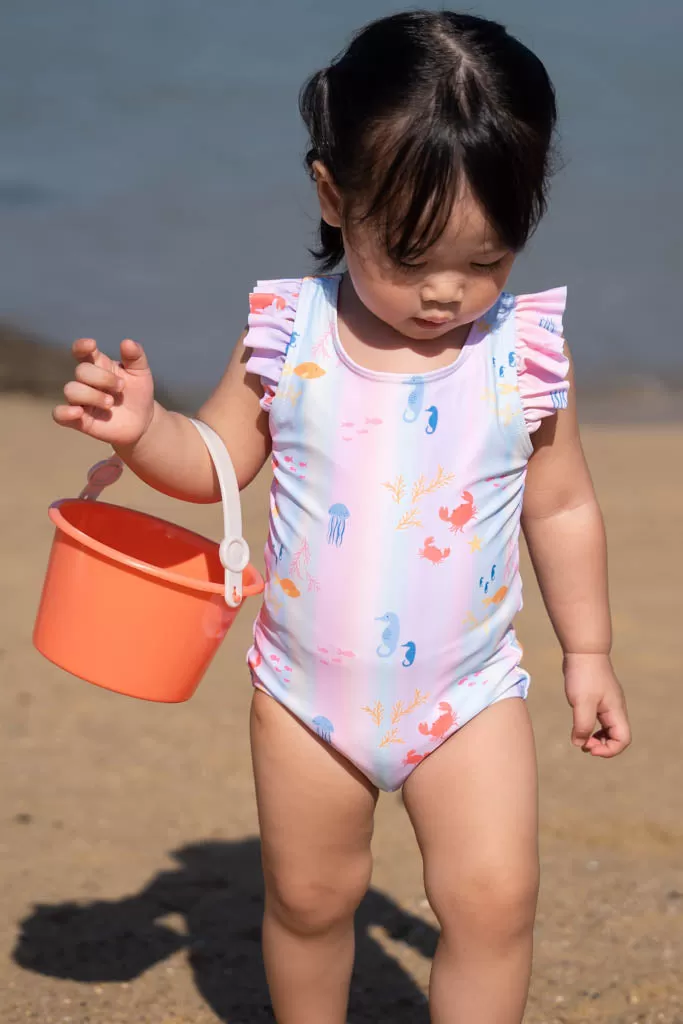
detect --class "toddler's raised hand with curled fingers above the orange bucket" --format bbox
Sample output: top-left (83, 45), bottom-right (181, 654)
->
top-left (52, 338), bottom-right (155, 445)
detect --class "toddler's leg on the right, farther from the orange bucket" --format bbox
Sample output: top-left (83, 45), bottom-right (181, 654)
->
top-left (403, 698), bottom-right (539, 1024)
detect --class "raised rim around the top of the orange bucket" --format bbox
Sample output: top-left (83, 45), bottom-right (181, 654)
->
top-left (47, 498), bottom-right (265, 598)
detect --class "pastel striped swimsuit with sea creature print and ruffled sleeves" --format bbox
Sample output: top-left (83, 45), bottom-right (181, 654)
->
top-left (245, 275), bottom-right (568, 791)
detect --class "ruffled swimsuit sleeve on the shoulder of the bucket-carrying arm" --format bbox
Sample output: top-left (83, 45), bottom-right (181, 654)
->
top-left (244, 279), bottom-right (301, 412)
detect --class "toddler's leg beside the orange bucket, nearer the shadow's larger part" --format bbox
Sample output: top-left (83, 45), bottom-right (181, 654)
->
top-left (251, 690), bottom-right (377, 1024)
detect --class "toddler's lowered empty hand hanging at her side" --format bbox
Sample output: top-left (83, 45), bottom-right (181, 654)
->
top-left (564, 654), bottom-right (631, 758)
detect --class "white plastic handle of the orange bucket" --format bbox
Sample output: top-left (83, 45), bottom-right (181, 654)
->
top-left (79, 419), bottom-right (249, 608)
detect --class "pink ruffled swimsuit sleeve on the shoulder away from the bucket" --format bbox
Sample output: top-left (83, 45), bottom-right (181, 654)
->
top-left (514, 288), bottom-right (569, 434)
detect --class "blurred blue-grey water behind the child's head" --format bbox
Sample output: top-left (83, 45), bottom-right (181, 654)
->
top-left (0, 0), bottom-right (683, 399)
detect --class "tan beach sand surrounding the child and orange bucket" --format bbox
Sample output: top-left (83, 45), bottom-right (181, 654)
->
top-left (0, 395), bottom-right (683, 1024)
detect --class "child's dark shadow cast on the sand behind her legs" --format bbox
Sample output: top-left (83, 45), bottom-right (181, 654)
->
top-left (13, 839), bottom-right (436, 1024)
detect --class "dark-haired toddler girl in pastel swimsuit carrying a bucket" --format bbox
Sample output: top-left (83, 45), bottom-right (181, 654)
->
top-left (54, 11), bottom-right (630, 1024)
